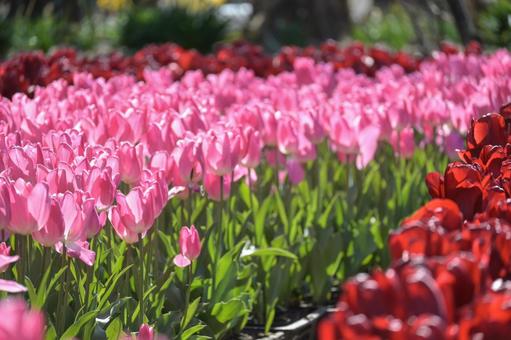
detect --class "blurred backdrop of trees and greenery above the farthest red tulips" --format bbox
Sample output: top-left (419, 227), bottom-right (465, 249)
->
top-left (0, 0), bottom-right (511, 56)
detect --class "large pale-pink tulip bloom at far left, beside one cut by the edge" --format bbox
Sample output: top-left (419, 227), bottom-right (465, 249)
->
top-left (8, 178), bottom-right (51, 235)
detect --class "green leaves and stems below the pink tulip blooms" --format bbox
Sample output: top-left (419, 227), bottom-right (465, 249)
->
top-left (5, 143), bottom-right (447, 339)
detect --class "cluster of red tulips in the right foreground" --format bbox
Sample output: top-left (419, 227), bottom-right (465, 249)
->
top-left (320, 104), bottom-right (511, 340)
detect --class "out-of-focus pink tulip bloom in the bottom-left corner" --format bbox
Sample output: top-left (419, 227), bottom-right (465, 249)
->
top-left (0, 298), bottom-right (45, 340)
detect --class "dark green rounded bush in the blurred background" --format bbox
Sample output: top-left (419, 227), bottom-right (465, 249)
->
top-left (121, 7), bottom-right (226, 52)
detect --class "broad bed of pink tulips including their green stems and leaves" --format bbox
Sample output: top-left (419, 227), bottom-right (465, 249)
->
top-left (0, 47), bottom-right (511, 339)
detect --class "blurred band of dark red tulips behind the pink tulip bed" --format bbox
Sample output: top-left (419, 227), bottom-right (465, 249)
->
top-left (0, 42), bottom-right (424, 98)
